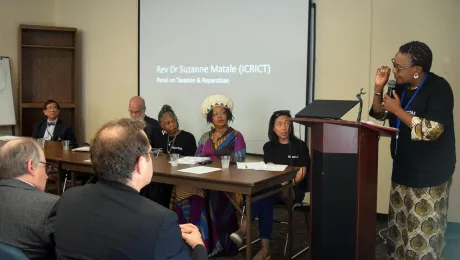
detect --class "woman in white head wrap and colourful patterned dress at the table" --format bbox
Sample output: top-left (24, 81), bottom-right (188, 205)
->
top-left (181, 95), bottom-right (246, 255)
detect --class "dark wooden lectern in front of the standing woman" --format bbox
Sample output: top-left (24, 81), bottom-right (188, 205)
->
top-left (292, 118), bottom-right (395, 260)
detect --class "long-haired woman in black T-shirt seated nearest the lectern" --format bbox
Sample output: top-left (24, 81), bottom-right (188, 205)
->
top-left (230, 110), bottom-right (310, 260)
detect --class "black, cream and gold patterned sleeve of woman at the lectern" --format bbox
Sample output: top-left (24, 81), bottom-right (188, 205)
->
top-left (411, 116), bottom-right (444, 141)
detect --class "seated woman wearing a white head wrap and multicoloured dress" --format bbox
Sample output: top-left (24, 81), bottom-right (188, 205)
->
top-left (196, 95), bottom-right (246, 253)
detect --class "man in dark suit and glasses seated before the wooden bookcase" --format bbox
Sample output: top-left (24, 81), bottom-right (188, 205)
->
top-left (32, 99), bottom-right (77, 146)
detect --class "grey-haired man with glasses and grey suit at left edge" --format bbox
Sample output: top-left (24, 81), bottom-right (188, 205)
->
top-left (0, 138), bottom-right (59, 259)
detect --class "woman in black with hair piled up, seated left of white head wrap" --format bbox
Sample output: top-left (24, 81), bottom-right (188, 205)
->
top-left (141, 105), bottom-right (196, 208)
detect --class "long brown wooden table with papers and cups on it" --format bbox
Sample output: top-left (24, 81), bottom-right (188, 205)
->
top-left (0, 141), bottom-right (298, 259)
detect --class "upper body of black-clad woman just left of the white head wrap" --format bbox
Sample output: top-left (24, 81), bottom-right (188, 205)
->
top-left (152, 105), bottom-right (196, 156)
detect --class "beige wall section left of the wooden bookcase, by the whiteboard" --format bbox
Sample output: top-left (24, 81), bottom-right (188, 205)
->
top-left (0, 0), bottom-right (54, 135)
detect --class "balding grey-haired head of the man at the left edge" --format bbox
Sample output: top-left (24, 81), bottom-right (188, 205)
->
top-left (0, 138), bottom-right (45, 179)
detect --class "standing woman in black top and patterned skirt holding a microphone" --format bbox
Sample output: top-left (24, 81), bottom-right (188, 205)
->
top-left (370, 42), bottom-right (456, 259)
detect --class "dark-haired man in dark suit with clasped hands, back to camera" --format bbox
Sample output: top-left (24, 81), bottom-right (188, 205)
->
top-left (55, 119), bottom-right (207, 260)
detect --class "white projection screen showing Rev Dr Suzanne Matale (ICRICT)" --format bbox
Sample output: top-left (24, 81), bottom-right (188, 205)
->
top-left (139, 0), bottom-right (310, 154)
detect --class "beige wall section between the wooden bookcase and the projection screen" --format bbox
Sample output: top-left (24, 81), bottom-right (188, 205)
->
top-left (55, 0), bottom-right (137, 141)
